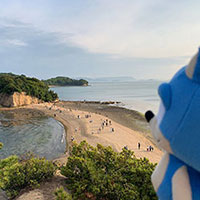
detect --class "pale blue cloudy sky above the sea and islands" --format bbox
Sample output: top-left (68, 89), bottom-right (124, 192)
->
top-left (0, 0), bottom-right (200, 80)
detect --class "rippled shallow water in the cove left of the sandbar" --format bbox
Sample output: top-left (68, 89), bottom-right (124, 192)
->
top-left (0, 115), bottom-right (66, 159)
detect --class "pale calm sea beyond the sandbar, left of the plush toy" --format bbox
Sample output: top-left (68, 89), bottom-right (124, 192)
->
top-left (51, 80), bottom-right (161, 113)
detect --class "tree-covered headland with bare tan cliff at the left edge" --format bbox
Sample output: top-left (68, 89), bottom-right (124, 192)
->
top-left (0, 73), bottom-right (58, 107)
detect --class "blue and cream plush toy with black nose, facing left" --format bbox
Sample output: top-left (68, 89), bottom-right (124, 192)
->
top-left (145, 50), bottom-right (200, 200)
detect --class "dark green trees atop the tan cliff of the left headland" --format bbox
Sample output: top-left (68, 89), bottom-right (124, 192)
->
top-left (0, 73), bottom-right (58, 102)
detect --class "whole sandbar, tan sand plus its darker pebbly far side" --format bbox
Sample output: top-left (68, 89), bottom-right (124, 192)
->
top-left (0, 101), bottom-right (162, 165)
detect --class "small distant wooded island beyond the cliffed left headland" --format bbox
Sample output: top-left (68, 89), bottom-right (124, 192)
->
top-left (44, 76), bottom-right (88, 86)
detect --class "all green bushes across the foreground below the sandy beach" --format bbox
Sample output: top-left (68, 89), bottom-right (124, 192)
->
top-left (0, 141), bottom-right (157, 200)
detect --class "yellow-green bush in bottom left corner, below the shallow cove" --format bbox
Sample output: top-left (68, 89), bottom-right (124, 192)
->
top-left (0, 155), bottom-right (55, 197)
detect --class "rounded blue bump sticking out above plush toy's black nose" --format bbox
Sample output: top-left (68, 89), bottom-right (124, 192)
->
top-left (158, 83), bottom-right (172, 110)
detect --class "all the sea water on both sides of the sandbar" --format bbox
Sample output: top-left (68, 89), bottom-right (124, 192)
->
top-left (0, 80), bottom-right (161, 159)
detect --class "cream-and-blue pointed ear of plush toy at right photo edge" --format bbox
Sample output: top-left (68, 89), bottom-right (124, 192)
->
top-left (185, 49), bottom-right (200, 83)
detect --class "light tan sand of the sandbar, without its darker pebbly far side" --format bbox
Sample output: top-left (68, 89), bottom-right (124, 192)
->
top-left (25, 102), bottom-right (162, 163)
